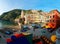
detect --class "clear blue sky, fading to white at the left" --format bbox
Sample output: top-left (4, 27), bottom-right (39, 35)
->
top-left (0, 0), bottom-right (60, 15)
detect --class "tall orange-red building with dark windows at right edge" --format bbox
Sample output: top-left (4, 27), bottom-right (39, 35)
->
top-left (47, 10), bottom-right (60, 28)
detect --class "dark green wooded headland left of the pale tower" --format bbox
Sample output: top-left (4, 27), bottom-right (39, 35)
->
top-left (0, 9), bottom-right (21, 21)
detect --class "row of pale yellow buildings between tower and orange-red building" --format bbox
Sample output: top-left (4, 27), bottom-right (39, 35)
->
top-left (25, 10), bottom-right (46, 23)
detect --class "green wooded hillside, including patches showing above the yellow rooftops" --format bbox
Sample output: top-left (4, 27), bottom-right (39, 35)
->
top-left (0, 9), bottom-right (42, 21)
